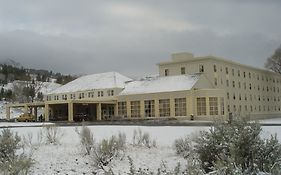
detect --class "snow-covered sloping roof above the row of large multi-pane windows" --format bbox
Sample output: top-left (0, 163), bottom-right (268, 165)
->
top-left (119, 74), bottom-right (200, 95)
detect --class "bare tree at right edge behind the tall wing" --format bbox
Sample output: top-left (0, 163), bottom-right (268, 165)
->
top-left (265, 45), bottom-right (281, 74)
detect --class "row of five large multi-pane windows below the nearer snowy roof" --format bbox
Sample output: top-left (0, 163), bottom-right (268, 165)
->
top-left (118, 98), bottom-right (186, 117)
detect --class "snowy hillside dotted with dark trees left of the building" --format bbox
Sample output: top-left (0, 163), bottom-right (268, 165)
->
top-left (0, 59), bottom-right (76, 102)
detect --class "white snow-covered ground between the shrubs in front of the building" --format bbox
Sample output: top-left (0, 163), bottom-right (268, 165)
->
top-left (0, 123), bottom-right (281, 175)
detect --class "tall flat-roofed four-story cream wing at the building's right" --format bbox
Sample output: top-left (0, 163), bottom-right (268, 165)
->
top-left (158, 53), bottom-right (281, 117)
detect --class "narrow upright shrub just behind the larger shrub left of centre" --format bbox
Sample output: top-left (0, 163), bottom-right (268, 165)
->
top-left (75, 125), bottom-right (95, 155)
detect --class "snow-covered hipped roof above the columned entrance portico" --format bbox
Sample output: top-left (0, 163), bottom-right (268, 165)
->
top-left (49, 72), bottom-right (132, 94)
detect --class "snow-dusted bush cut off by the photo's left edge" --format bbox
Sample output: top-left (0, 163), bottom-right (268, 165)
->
top-left (0, 129), bottom-right (33, 175)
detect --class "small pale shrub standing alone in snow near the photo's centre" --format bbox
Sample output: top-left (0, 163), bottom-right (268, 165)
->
top-left (133, 128), bottom-right (156, 148)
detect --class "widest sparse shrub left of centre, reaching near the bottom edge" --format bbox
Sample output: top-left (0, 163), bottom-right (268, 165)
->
top-left (93, 133), bottom-right (126, 174)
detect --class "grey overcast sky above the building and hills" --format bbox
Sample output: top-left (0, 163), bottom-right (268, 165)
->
top-left (0, 0), bottom-right (281, 77)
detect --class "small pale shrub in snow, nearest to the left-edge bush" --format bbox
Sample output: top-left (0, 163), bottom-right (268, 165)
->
top-left (43, 125), bottom-right (64, 145)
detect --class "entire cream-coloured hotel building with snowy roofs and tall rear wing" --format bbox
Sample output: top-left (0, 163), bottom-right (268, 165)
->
top-left (7, 53), bottom-right (281, 121)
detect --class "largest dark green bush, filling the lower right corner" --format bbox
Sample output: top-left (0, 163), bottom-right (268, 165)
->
top-left (192, 120), bottom-right (281, 175)
